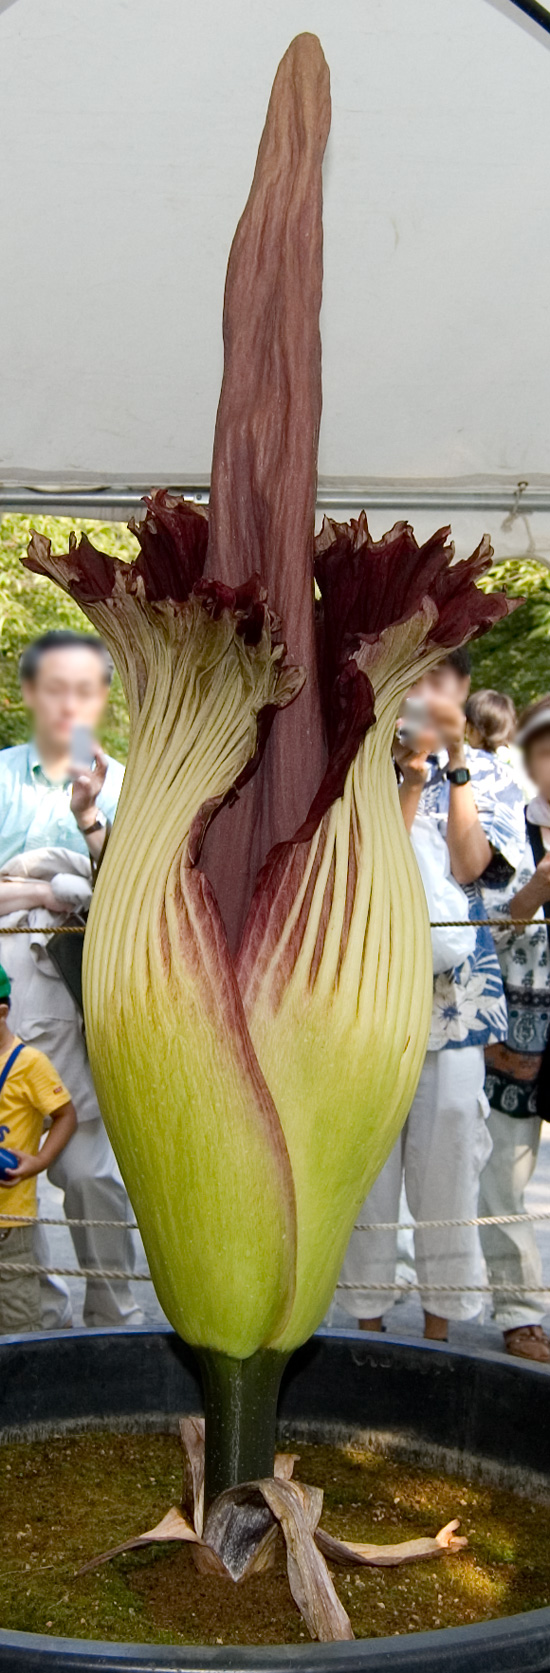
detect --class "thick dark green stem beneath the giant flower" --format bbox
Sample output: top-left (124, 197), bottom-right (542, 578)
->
top-left (196, 1348), bottom-right (289, 1504)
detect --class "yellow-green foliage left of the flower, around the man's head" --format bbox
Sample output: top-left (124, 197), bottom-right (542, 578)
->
top-left (0, 517), bottom-right (139, 761)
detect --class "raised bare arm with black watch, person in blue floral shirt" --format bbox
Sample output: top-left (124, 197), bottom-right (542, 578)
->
top-left (431, 698), bottom-right (493, 885)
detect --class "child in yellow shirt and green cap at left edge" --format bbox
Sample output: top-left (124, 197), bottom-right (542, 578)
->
top-left (0, 965), bottom-right (77, 1335)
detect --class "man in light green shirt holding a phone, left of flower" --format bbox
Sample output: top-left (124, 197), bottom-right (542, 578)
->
top-left (0, 631), bottom-right (140, 1328)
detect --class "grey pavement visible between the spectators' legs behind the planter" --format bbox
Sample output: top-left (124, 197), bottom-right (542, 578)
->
top-left (38, 1126), bottom-right (550, 1348)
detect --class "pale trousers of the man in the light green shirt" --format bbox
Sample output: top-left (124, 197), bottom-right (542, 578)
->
top-left (35, 1116), bottom-right (142, 1330)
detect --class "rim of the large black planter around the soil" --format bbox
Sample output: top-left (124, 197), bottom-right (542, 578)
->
top-left (0, 1325), bottom-right (550, 1673)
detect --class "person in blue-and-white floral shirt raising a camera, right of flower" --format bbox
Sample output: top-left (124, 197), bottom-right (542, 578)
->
top-left (338, 651), bottom-right (525, 1342)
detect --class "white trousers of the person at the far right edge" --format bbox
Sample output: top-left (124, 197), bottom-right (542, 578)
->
top-left (480, 1109), bottom-right (548, 1330)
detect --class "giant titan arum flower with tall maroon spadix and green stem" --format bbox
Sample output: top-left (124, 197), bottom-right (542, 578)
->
top-left (27, 35), bottom-right (507, 1496)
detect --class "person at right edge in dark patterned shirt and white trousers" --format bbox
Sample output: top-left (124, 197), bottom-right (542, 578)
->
top-left (480, 696), bottom-right (550, 1363)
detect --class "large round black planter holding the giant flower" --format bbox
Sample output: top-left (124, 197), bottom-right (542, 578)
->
top-left (0, 1330), bottom-right (550, 1673)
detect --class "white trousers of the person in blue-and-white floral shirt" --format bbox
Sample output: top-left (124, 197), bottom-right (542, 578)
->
top-left (336, 1046), bottom-right (491, 1318)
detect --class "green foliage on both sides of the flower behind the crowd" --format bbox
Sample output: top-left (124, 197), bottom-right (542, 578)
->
top-left (0, 515), bottom-right (550, 761)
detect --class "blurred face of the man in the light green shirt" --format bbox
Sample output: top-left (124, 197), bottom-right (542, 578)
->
top-left (22, 646), bottom-right (109, 755)
